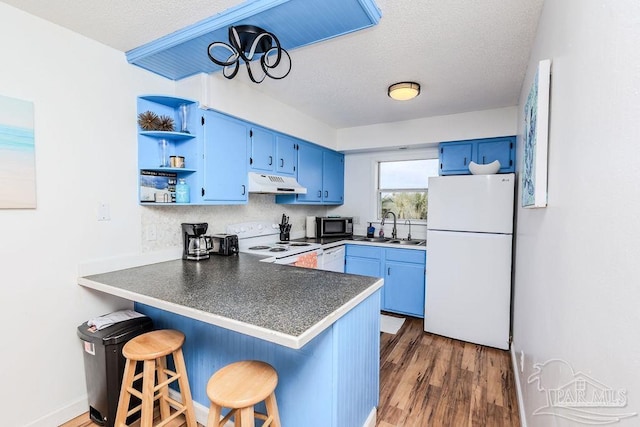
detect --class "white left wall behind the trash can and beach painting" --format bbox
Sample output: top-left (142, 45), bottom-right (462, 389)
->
top-left (0, 3), bottom-right (174, 426)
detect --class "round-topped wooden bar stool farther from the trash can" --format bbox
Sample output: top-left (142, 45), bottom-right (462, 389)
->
top-left (207, 360), bottom-right (281, 427)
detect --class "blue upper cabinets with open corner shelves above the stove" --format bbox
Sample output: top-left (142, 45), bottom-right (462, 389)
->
top-left (138, 95), bottom-right (344, 205)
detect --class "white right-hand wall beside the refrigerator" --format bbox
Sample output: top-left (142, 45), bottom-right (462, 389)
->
top-left (513, 0), bottom-right (640, 426)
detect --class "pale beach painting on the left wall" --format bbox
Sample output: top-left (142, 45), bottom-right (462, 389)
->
top-left (0, 95), bottom-right (36, 209)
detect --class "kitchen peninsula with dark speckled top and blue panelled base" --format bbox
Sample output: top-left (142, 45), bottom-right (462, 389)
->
top-left (78, 255), bottom-right (382, 427)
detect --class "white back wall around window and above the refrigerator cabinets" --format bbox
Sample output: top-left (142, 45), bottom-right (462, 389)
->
top-left (336, 107), bottom-right (518, 239)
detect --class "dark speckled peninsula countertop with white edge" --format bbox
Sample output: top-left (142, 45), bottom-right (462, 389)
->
top-left (78, 254), bottom-right (382, 348)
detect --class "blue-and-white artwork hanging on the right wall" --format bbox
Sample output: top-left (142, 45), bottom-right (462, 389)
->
top-left (522, 59), bottom-right (551, 208)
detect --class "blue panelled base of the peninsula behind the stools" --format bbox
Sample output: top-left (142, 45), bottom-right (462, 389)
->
top-left (135, 291), bottom-right (380, 427)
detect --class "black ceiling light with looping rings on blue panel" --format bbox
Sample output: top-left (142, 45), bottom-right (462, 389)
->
top-left (207, 25), bottom-right (291, 83)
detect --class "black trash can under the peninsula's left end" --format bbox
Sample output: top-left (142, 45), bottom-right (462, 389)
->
top-left (78, 316), bottom-right (153, 427)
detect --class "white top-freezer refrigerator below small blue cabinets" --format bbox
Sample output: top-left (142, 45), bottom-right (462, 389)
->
top-left (424, 174), bottom-right (515, 350)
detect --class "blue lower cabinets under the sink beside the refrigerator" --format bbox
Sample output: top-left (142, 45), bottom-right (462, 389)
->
top-left (345, 245), bottom-right (426, 317)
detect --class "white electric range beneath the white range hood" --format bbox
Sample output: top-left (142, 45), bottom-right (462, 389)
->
top-left (226, 221), bottom-right (322, 265)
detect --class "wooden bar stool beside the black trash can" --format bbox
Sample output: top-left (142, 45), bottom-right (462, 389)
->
top-left (114, 329), bottom-right (196, 427)
